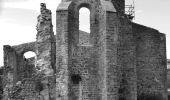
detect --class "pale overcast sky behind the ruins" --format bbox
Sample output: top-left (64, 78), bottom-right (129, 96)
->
top-left (0, 0), bottom-right (170, 66)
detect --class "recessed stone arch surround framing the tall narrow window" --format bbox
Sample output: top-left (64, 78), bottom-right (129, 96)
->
top-left (64, 0), bottom-right (100, 45)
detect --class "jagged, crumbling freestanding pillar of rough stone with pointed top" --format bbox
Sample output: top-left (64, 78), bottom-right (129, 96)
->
top-left (36, 3), bottom-right (55, 100)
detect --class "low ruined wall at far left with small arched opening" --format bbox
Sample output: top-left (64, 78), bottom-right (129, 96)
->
top-left (3, 35), bottom-right (36, 100)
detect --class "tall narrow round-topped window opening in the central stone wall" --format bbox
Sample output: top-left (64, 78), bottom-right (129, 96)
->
top-left (79, 7), bottom-right (91, 45)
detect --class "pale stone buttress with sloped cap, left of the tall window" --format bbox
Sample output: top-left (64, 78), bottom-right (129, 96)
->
top-left (56, 2), bottom-right (70, 100)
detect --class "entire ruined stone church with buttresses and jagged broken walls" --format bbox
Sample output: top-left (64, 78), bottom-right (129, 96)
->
top-left (1, 0), bottom-right (167, 100)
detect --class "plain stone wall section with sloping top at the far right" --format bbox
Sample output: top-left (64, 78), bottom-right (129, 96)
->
top-left (133, 24), bottom-right (167, 100)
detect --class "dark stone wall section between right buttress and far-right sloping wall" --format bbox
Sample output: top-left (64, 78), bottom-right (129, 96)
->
top-left (115, 15), bottom-right (137, 100)
